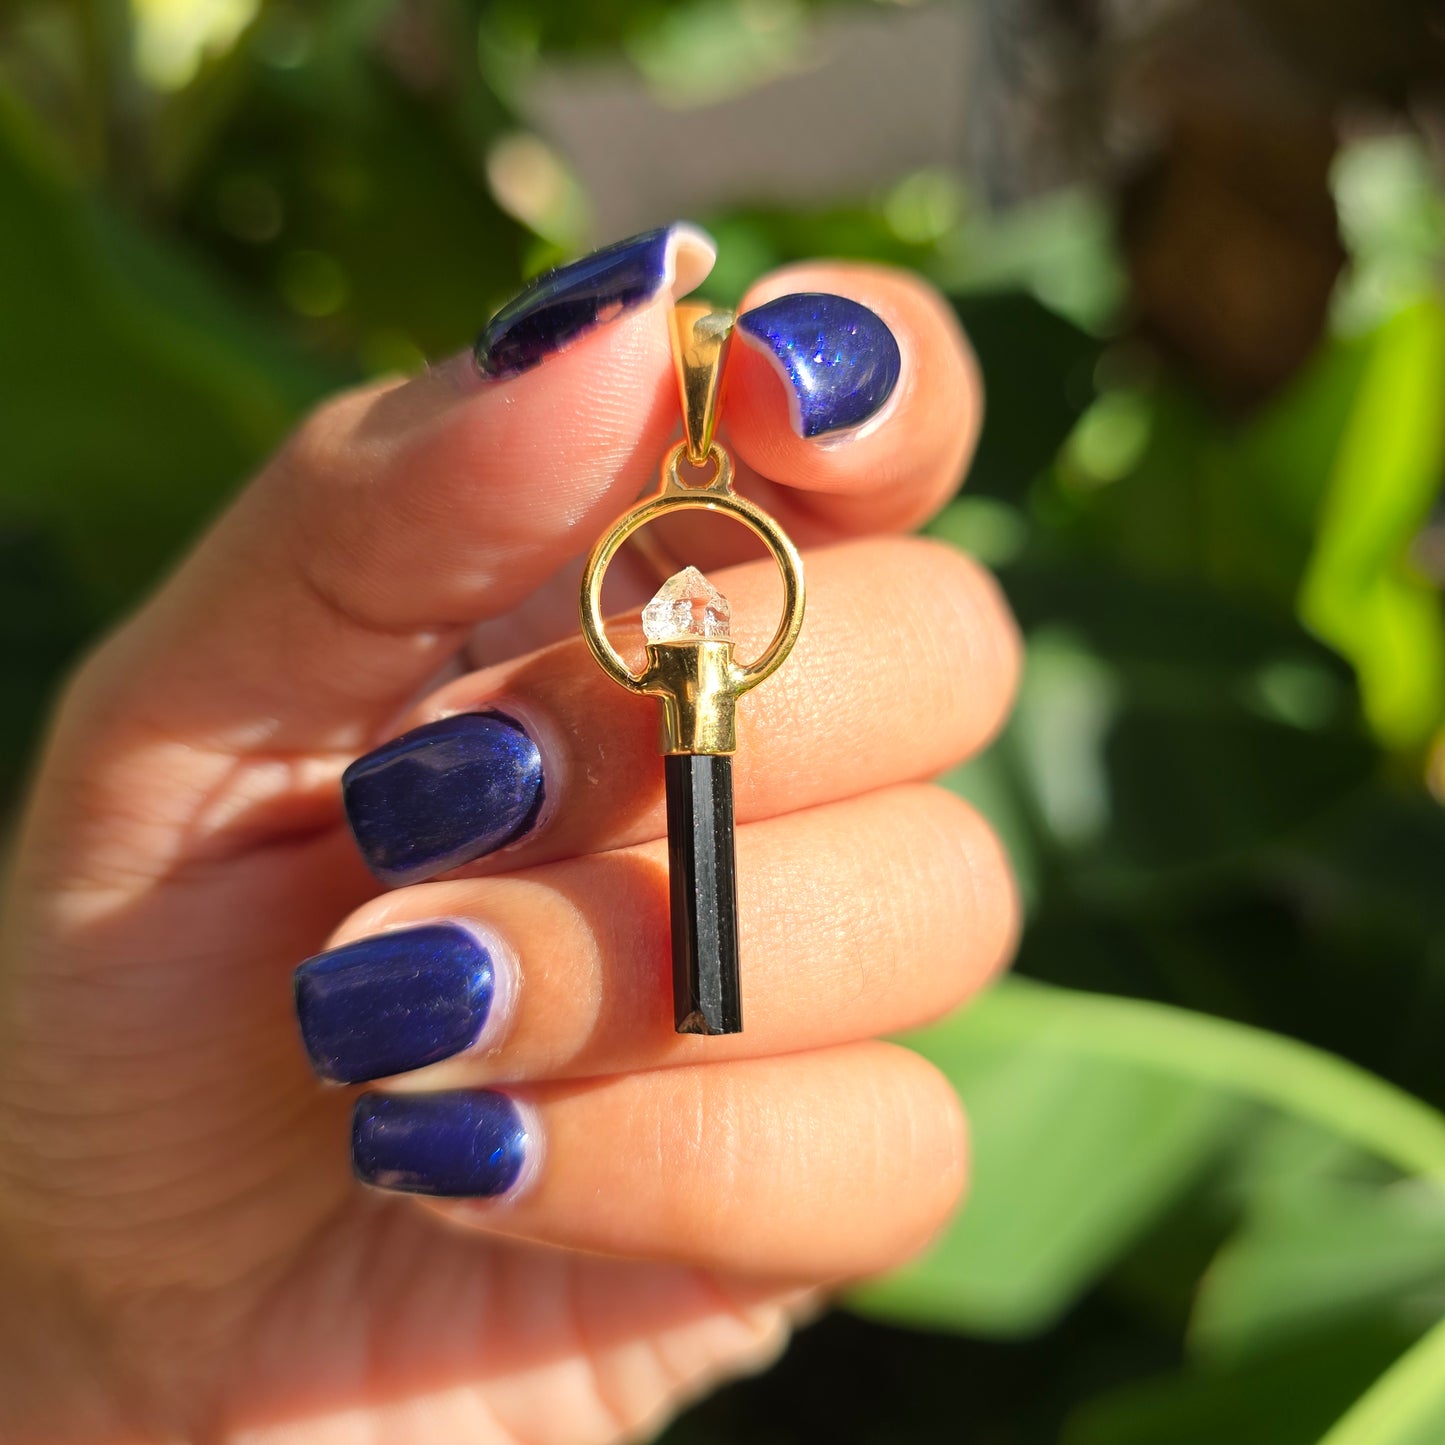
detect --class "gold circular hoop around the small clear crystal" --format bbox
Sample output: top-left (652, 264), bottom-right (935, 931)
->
top-left (581, 442), bottom-right (803, 692)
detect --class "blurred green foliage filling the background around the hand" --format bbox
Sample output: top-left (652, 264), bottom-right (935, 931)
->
top-left (0, 0), bottom-right (1445, 1445)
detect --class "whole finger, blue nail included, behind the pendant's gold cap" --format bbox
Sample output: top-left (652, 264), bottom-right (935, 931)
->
top-left (336, 538), bottom-right (1019, 884)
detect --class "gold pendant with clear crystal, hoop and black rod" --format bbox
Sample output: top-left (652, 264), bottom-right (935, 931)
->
top-left (581, 303), bottom-right (803, 1033)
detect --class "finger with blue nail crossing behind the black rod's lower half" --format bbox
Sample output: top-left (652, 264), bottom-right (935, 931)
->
top-left (296, 785), bottom-right (1019, 1090)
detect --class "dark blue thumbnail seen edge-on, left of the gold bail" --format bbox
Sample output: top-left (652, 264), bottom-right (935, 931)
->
top-left (475, 221), bottom-right (717, 377)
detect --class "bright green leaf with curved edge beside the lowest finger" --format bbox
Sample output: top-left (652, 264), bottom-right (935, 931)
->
top-left (853, 978), bottom-right (1445, 1334)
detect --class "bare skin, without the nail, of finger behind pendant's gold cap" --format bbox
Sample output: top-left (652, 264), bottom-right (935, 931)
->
top-left (378, 538), bottom-right (1020, 873)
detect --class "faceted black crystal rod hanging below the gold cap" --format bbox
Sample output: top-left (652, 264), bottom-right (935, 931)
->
top-left (663, 753), bottom-right (743, 1033)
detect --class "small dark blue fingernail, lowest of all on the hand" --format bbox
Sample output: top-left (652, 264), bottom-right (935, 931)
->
top-left (351, 1090), bottom-right (536, 1199)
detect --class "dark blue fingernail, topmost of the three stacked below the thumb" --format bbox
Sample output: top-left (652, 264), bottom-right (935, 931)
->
top-left (341, 712), bottom-right (545, 883)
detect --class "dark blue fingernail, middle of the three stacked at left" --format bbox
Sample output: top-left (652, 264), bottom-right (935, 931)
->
top-left (295, 922), bottom-right (510, 1084)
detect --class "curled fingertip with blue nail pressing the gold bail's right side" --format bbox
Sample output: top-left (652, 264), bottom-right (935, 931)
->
top-left (473, 262), bottom-right (983, 662)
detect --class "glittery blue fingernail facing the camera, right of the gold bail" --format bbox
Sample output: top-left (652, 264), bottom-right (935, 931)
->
top-left (737, 292), bottom-right (902, 436)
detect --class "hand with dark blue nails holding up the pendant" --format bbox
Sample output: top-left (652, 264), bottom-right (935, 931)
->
top-left (0, 228), bottom-right (1017, 1445)
